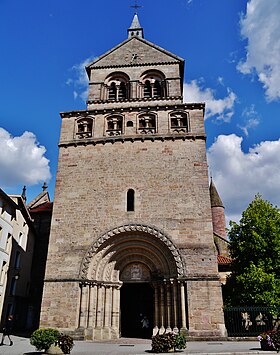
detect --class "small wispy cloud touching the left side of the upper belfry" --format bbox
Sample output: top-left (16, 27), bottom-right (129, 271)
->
top-left (66, 57), bottom-right (96, 102)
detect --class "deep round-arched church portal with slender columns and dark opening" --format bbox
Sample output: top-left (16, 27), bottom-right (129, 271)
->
top-left (78, 225), bottom-right (186, 339)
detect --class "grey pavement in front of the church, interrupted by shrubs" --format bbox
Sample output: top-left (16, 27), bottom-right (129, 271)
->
top-left (0, 336), bottom-right (276, 355)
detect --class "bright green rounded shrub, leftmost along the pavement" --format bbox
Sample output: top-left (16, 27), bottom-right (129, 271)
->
top-left (30, 328), bottom-right (60, 351)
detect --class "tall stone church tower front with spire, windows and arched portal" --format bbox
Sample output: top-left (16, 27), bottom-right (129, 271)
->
top-left (40, 15), bottom-right (226, 339)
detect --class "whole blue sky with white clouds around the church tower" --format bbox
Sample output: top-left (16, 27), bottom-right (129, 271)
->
top-left (0, 0), bottom-right (280, 224)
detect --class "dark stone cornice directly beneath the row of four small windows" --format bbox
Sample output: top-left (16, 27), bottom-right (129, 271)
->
top-left (58, 133), bottom-right (206, 148)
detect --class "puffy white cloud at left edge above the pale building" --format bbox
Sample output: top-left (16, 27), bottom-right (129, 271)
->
top-left (0, 127), bottom-right (51, 187)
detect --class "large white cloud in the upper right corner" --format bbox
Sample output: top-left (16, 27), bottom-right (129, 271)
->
top-left (237, 0), bottom-right (280, 101)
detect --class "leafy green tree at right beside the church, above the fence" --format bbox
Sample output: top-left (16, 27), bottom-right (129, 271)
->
top-left (224, 195), bottom-right (280, 307)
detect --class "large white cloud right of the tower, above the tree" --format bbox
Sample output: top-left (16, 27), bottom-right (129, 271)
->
top-left (208, 134), bottom-right (280, 227)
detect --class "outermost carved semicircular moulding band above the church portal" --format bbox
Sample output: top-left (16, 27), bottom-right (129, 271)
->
top-left (80, 224), bottom-right (185, 279)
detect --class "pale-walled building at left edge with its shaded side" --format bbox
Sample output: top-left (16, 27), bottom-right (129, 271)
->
top-left (0, 189), bottom-right (35, 329)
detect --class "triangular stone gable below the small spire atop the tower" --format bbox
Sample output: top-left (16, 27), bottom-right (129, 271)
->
top-left (86, 36), bottom-right (184, 76)
